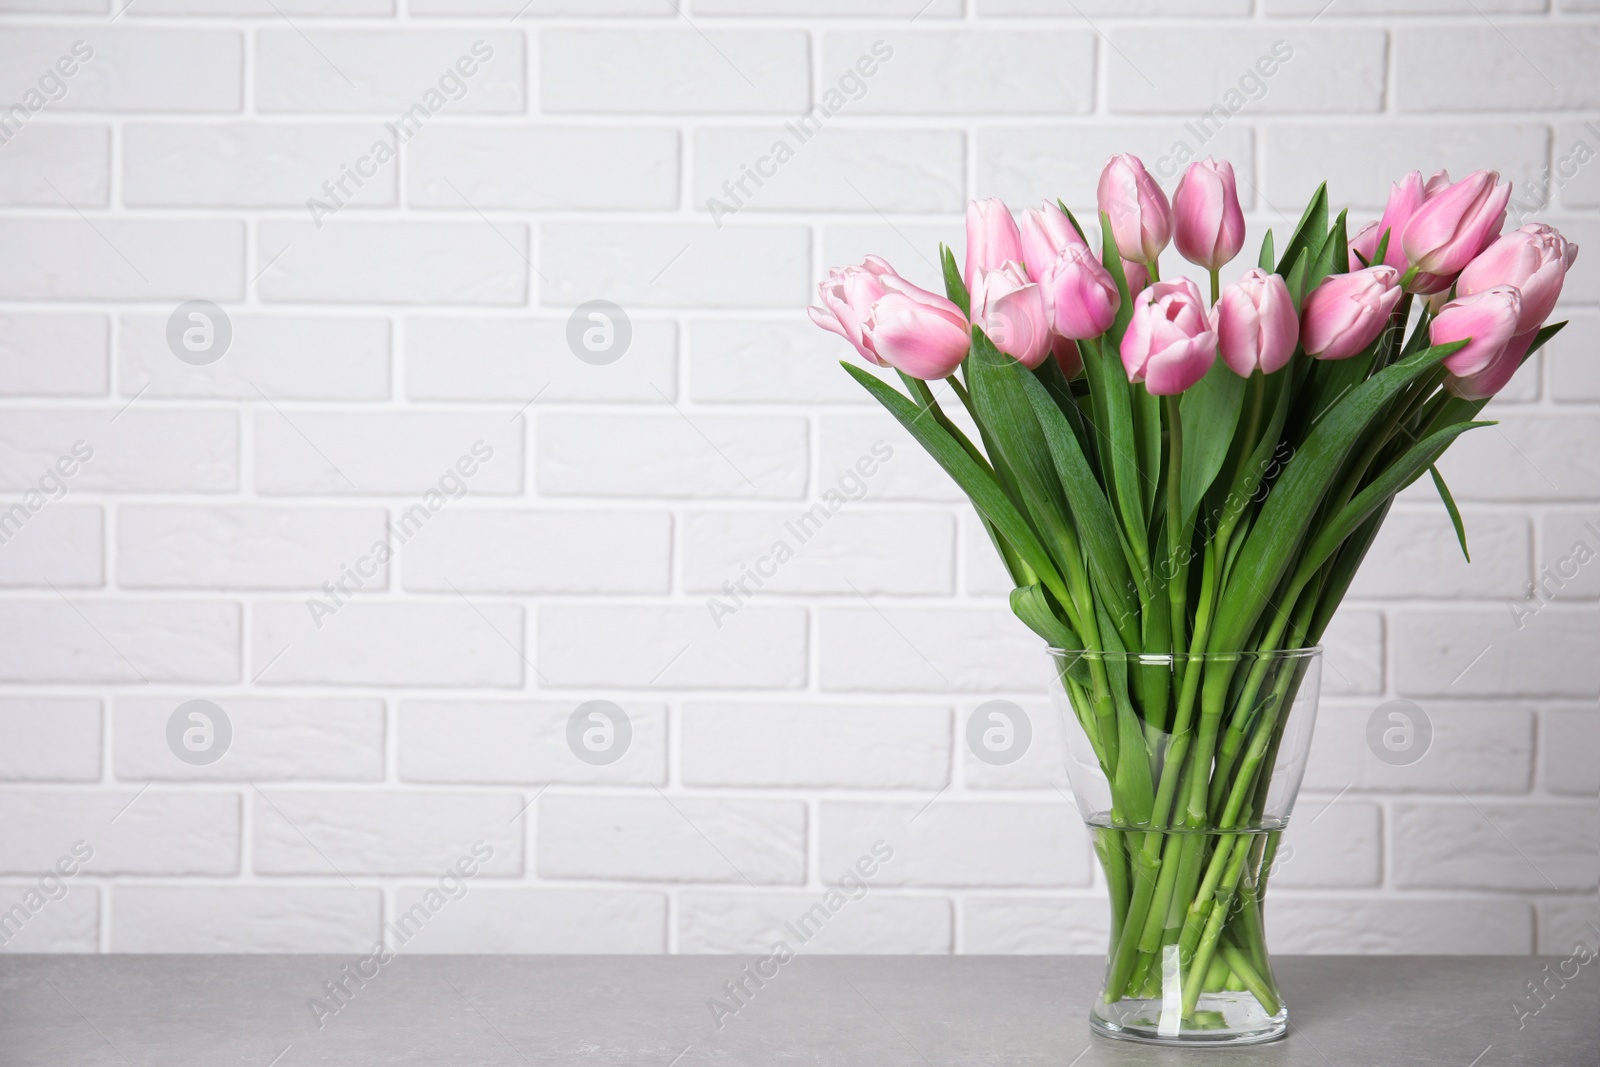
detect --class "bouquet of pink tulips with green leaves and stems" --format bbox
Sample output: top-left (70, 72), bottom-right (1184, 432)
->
top-left (810, 155), bottom-right (1578, 1017)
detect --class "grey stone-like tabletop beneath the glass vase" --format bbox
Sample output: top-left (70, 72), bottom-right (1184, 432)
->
top-left (0, 955), bottom-right (1600, 1067)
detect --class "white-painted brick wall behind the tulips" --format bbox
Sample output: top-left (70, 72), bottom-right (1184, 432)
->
top-left (0, 0), bottom-right (1600, 953)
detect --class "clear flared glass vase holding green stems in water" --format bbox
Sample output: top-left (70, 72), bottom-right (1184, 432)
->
top-left (1050, 648), bottom-right (1322, 1045)
